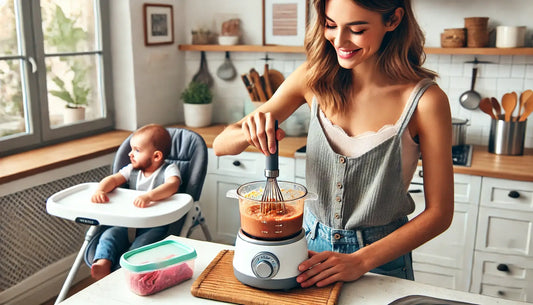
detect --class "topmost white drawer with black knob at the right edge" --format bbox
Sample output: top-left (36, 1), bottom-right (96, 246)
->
top-left (480, 178), bottom-right (533, 212)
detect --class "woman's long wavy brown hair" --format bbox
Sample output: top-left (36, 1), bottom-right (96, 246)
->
top-left (305, 0), bottom-right (437, 110)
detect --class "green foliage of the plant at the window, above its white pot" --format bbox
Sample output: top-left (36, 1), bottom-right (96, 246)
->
top-left (45, 5), bottom-right (91, 108)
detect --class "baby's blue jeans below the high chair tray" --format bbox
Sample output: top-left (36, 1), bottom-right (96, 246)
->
top-left (93, 225), bottom-right (169, 270)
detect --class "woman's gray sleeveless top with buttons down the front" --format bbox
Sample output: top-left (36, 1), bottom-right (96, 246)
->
top-left (306, 79), bottom-right (435, 230)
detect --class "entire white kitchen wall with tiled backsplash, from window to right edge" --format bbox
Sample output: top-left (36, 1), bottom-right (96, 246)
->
top-left (112, 0), bottom-right (533, 147)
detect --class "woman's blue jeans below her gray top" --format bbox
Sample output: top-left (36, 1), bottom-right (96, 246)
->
top-left (303, 210), bottom-right (414, 280)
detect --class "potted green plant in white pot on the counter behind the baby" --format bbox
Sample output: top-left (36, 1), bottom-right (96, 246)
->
top-left (181, 81), bottom-right (213, 127)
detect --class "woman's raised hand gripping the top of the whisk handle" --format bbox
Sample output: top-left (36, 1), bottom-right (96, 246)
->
top-left (241, 111), bottom-right (285, 155)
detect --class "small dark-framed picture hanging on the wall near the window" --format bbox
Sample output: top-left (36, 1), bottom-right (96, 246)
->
top-left (143, 3), bottom-right (174, 46)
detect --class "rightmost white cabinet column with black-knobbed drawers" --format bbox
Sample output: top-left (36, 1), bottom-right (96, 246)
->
top-left (471, 178), bottom-right (533, 302)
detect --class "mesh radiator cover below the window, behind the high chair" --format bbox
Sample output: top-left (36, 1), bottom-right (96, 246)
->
top-left (0, 166), bottom-right (111, 295)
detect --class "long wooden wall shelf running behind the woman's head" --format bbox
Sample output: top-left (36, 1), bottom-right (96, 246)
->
top-left (178, 44), bottom-right (533, 55)
